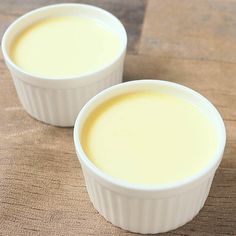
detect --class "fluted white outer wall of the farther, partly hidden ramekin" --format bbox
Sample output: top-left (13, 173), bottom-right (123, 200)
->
top-left (8, 61), bottom-right (123, 126)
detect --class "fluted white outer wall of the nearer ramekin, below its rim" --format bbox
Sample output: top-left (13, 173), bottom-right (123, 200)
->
top-left (83, 168), bottom-right (214, 234)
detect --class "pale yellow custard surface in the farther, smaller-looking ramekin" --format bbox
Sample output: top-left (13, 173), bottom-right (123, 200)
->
top-left (10, 16), bottom-right (121, 79)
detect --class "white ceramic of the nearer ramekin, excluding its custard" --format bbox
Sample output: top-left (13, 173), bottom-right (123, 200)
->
top-left (74, 80), bottom-right (226, 234)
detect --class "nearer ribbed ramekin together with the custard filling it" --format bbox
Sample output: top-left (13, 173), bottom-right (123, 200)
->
top-left (74, 80), bottom-right (226, 234)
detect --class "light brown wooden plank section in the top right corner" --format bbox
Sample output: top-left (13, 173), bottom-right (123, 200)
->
top-left (140, 0), bottom-right (236, 62)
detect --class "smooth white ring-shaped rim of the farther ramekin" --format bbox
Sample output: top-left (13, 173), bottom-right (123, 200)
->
top-left (1, 3), bottom-right (128, 82)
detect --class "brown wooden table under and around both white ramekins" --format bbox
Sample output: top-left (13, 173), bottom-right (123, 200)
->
top-left (0, 0), bottom-right (236, 236)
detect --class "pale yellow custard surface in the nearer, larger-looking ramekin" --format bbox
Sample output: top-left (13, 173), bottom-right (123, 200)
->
top-left (80, 91), bottom-right (218, 184)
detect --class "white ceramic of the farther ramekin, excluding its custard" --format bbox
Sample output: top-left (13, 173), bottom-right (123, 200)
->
top-left (2, 4), bottom-right (127, 126)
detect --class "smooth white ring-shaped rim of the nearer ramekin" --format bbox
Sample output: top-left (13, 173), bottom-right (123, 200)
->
top-left (73, 80), bottom-right (226, 192)
